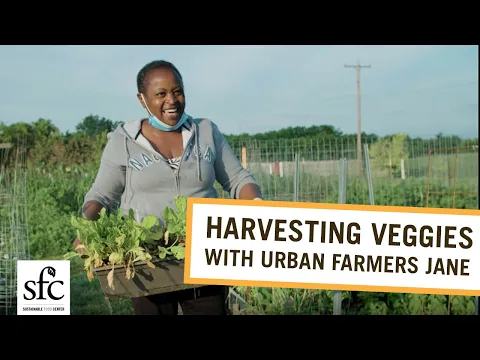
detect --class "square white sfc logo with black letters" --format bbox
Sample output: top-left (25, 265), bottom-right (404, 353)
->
top-left (17, 260), bottom-right (70, 315)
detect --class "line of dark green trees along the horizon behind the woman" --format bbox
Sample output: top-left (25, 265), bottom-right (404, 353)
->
top-left (0, 115), bottom-right (478, 166)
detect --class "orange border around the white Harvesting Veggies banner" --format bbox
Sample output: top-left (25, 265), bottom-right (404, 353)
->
top-left (184, 198), bottom-right (480, 296)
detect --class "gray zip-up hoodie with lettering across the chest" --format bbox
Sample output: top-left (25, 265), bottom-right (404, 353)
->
top-left (84, 117), bottom-right (256, 223)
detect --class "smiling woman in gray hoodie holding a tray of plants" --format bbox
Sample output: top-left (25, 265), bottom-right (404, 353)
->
top-left (74, 61), bottom-right (262, 315)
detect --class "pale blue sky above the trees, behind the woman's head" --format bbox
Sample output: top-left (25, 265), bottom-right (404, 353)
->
top-left (0, 45), bottom-right (478, 137)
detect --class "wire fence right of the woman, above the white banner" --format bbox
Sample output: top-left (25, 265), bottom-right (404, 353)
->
top-left (216, 137), bottom-right (478, 209)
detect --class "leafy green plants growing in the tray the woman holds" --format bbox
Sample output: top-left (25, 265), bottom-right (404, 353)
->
top-left (64, 196), bottom-right (187, 288)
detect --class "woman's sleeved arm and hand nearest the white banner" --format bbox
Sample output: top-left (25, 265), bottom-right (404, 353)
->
top-left (212, 122), bottom-right (262, 200)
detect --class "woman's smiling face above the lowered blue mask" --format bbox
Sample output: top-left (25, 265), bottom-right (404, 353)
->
top-left (138, 68), bottom-right (185, 126)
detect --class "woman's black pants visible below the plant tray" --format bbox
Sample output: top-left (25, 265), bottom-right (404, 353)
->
top-left (132, 286), bottom-right (227, 315)
